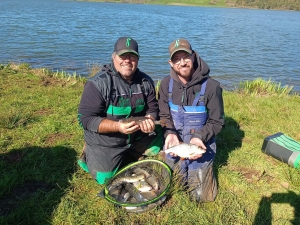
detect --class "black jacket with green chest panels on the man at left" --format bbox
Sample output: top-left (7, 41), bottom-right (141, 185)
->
top-left (78, 64), bottom-right (158, 148)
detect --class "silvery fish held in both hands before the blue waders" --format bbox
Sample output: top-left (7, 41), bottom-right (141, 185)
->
top-left (164, 143), bottom-right (206, 158)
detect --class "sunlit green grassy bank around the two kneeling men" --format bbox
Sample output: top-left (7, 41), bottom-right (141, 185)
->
top-left (0, 64), bottom-right (300, 225)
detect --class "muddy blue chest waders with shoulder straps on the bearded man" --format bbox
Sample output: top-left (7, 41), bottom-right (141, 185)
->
top-left (166, 78), bottom-right (217, 202)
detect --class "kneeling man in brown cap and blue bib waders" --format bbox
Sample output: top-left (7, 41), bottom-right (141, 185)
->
top-left (158, 38), bottom-right (224, 202)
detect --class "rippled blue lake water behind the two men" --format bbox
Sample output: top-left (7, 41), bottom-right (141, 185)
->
top-left (0, 0), bottom-right (300, 91)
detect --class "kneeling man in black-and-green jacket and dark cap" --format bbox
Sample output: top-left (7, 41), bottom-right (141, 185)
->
top-left (78, 37), bottom-right (162, 184)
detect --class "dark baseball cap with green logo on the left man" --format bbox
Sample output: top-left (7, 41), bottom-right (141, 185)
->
top-left (114, 37), bottom-right (140, 57)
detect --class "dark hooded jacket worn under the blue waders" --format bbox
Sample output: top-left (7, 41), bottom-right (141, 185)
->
top-left (158, 51), bottom-right (225, 143)
